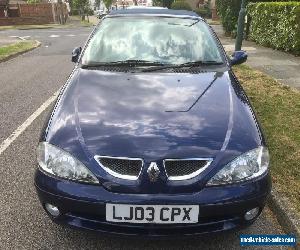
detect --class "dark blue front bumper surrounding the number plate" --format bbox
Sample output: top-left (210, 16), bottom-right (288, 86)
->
top-left (35, 170), bottom-right (271, 237)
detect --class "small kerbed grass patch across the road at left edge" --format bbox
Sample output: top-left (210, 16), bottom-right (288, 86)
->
top-left (0, 41), bottom-right (40, 62)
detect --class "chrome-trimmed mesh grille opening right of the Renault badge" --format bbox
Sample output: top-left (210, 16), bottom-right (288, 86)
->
top-left (164, 159), bottom-right (211, 180)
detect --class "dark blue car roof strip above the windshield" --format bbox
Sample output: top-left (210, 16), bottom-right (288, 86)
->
top-left (107, 7), bottom-right (201, 18)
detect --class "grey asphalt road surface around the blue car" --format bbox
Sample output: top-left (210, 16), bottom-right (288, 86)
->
top-left (0, 28), bottom-right (283, 250)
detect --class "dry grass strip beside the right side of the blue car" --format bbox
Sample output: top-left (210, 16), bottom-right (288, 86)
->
top-left (234, 65), bottom-right (300, 214)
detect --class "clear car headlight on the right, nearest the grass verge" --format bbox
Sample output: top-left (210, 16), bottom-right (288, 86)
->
top-left (207, 147), bottom-right (269, 186)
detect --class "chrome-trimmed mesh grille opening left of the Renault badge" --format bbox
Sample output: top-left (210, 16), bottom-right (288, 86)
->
top-left (95, 156), bottom-right (143, 180)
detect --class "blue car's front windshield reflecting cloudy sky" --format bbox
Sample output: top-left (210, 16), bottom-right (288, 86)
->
top-left (82, 17), bottom-right (223, 65)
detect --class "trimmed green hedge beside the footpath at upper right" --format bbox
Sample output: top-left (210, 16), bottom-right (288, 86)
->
top-left (247, 2), bottom-right (300, 55)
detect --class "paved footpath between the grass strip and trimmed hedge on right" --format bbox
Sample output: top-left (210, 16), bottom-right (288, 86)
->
top-left (211, 25), bottom-right (300, 89)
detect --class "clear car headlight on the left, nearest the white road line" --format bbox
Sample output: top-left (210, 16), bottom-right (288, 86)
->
top-left (37, 142), bottom-right (99, 184)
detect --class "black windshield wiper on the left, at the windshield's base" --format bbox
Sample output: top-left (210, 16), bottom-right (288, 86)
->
top-left (81, 60), bottom-right (164, 69)
